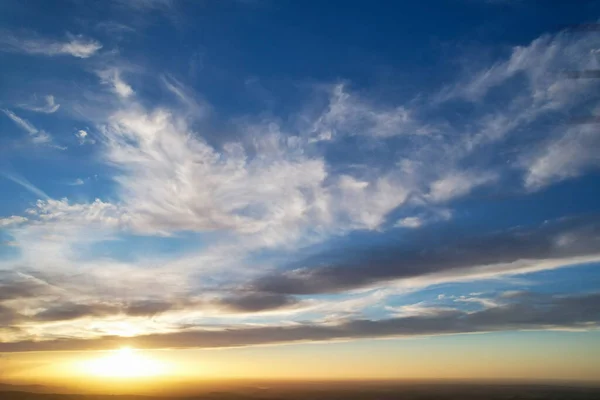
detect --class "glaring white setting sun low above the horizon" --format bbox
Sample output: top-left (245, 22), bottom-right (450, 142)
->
top-left (83, 347), bottom-right (166, 378)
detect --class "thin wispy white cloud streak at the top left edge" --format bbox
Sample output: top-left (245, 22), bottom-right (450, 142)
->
top-left (0, 32), bottom-right (102, 58)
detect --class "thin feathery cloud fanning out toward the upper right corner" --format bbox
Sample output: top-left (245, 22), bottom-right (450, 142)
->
top-left (433, 33), bottom-right (600, 178)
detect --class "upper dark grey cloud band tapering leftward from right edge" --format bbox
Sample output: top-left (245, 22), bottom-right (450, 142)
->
top-left (249, 215), bottom-right (600, 295)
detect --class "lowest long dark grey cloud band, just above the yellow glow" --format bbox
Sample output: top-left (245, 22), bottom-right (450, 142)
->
top-left (0, 293), bottom-right (600, 352)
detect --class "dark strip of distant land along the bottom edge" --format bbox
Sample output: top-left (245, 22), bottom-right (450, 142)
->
top-left (0, 383), bottom-right (600, 400)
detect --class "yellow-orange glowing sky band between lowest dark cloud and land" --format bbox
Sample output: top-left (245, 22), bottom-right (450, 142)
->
top-left (0, 332), bottom-right (600, 394)
